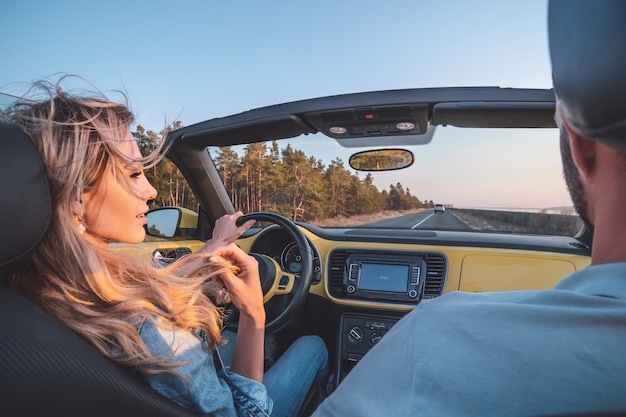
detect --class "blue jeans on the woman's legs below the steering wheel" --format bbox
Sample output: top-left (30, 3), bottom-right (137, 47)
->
top-left (219, 331), bottom-right (328, 417)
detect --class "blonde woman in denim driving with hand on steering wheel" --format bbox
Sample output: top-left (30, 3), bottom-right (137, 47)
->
top-left (3, 78), bottom-right (327, 416)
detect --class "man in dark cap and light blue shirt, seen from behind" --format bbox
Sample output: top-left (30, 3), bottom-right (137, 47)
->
top-left (314, 0), bottom-right (626, 417)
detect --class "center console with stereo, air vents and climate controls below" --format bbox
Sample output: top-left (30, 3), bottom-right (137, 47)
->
top-left (328, 249), bottom-right (447, 386)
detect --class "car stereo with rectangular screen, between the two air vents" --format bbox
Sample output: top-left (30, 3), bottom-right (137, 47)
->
top-left (343, 251), bottom-right (426, 303)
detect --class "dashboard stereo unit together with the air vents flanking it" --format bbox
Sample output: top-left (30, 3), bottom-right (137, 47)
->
top-left (328, 250), bottom-right (446, 305)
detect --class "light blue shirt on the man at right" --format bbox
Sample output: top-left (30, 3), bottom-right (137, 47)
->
top-left (314, 263), bottom-right (626, 417)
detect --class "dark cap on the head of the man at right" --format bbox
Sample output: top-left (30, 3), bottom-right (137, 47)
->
top-left (548, 0), bottom-right (626, 151)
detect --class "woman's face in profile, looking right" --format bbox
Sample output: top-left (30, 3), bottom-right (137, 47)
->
top-left (84, 131), bottom-right (157, 243)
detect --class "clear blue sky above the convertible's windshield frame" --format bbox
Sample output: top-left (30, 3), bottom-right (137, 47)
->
top-left (0, 0), bottom-right (569, 207)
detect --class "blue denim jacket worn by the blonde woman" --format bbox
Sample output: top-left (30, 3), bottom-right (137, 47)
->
top-left (138, 320), bottom-right (273, 417)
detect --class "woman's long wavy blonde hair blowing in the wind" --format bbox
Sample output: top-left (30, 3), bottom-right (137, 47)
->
top-left (3, 77), bottom-right (229, 372)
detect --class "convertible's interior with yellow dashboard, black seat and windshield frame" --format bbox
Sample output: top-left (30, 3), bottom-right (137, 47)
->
top-left (0, 87), bottom-right (591, 416)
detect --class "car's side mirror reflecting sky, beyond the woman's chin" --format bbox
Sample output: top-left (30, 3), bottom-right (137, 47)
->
top-left (146, 207), bottom-right (198, 239)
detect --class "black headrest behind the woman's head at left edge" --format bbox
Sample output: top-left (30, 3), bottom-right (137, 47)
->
top-left (0, 123), bottom-right (51, 266)
